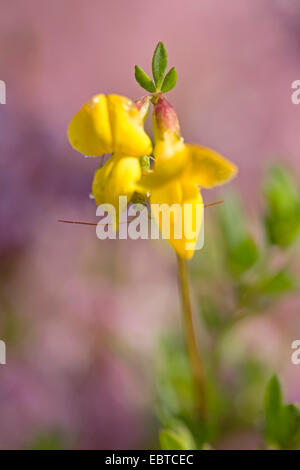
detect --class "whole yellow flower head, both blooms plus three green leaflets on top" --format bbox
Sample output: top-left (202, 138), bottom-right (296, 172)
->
top-left (68, 43), bottom-right (237, 259)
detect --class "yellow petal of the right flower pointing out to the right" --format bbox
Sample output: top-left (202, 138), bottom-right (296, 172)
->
top-left (184, 144), bottom-right (237, 188)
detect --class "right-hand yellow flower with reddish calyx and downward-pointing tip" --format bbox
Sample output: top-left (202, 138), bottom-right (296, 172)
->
top-left (141, 97), bottom-right (237, 259)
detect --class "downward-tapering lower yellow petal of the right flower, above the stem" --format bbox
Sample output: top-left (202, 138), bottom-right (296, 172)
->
top-left (151, 180), bottom-right (203, 259)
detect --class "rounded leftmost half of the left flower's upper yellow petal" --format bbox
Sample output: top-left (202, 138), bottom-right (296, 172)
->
top-left (68, 95), bottom-right (113, 156)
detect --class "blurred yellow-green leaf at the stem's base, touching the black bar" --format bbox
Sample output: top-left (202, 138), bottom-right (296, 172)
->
top-left (159, 426), bottom-right (196, 450)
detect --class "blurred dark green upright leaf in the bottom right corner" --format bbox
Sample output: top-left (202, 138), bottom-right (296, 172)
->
top-left (265, 376), bottom-right (300, 449)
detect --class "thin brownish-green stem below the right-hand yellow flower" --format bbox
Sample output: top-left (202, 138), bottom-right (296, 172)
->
top-left (177, 255), bottom-right (206, 419)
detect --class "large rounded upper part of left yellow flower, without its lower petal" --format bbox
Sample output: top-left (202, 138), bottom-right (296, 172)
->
top-left (68, 94), bottom-right (152, 157)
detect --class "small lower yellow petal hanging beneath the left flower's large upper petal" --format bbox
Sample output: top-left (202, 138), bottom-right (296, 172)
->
top-left (92, 155), bottom-right (142, 229)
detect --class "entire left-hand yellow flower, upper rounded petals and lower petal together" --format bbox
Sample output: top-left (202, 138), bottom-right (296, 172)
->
top-left (68, 94), bottom-right (152, 230)
